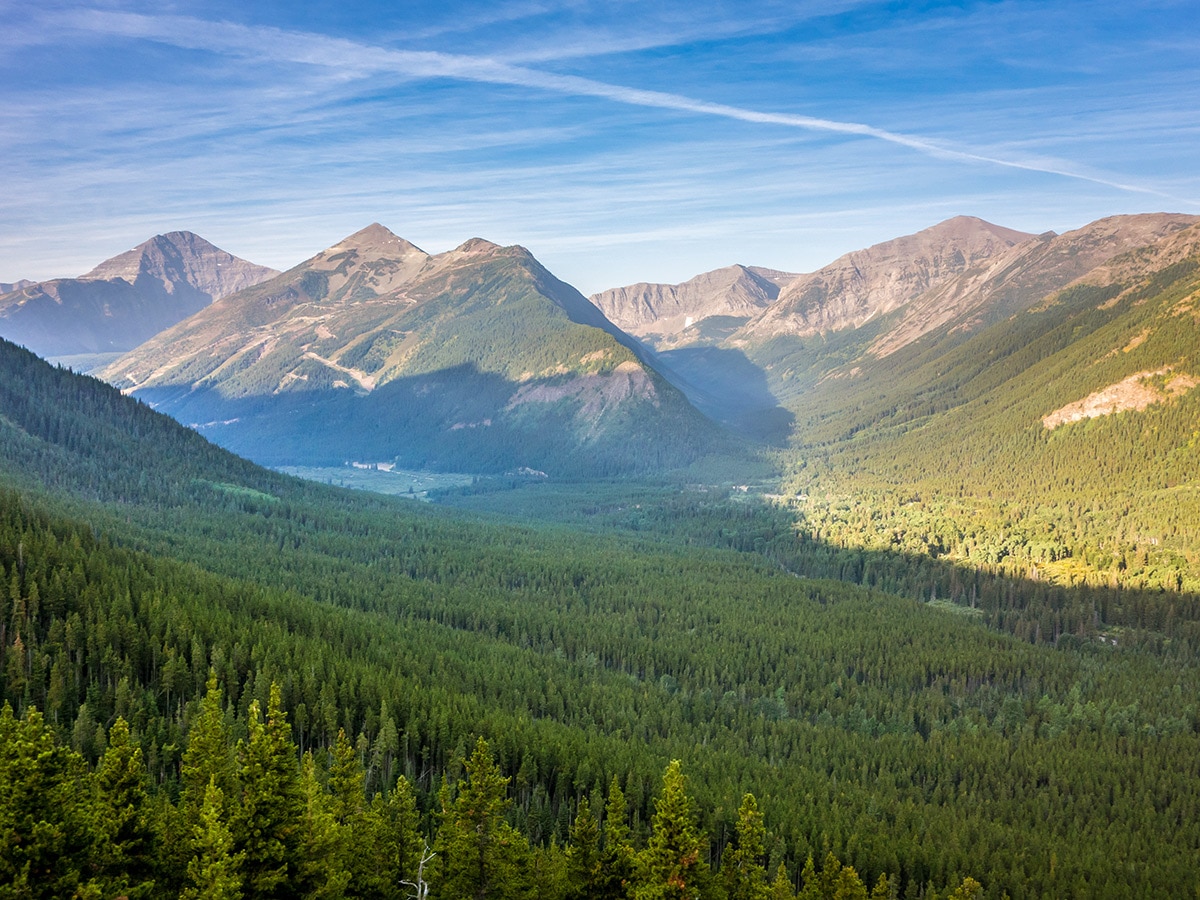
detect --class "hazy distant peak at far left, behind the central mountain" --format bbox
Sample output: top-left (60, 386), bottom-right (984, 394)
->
top-left (0, 232), bottom-right (277, 358)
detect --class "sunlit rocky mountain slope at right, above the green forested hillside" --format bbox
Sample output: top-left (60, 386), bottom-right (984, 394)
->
top-left (744, 214), bottom-right (1198, 403)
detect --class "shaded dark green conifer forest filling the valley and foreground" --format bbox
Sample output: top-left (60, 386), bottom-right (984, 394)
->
top-left (0, 344), bottom-right (1200, 898)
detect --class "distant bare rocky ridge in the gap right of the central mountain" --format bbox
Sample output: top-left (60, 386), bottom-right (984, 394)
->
top-left (588, 265), bottom-right (797, 341)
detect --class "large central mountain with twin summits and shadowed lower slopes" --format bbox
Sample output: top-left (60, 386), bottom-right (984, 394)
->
top-left (102, 224), bottom-right (713, 474)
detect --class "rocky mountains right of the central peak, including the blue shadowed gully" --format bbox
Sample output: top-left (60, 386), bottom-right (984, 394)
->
top-left (619, 214), bottom-right (1200, 440)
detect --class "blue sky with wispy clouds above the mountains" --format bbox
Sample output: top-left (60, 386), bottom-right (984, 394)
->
top-left (0, 0), bottom-right (1200, 293)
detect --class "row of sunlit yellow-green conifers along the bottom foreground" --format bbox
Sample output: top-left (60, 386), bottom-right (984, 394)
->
top-left (0, 676), bottom-right (983, 900)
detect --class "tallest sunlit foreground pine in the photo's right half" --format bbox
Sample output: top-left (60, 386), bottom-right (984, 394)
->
top-left (634, 760), bottom-right (712, 900)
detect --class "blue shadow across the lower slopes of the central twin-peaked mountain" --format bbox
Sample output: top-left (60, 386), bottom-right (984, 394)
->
top-left (138, 364), bottom-right (733, 478)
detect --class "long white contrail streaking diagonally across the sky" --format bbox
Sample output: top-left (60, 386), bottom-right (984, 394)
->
top-left (56, 10), bottom-right (1178, 202)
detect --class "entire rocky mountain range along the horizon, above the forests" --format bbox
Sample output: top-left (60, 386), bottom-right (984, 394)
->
top-left (0, 208), bottom-right (1200, 496)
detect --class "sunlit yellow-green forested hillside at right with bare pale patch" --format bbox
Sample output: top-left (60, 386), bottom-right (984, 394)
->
top-left (785, 227), bottom-right (1200, 602)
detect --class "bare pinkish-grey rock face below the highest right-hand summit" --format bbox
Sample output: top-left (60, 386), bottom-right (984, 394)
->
top-left (734, 216), bottom-right (1033, 343)
